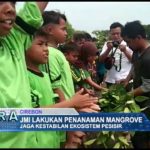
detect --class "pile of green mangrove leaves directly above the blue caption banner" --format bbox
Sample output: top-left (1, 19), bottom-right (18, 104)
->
top-left (99, 85), bottom-right (143, 112)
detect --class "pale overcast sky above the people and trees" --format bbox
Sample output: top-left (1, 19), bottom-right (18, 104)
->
top-left (17, 1), bottom-right (150, 33)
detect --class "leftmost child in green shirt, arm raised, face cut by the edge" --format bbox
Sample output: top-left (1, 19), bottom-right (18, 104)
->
top-left (0, 2), bottom-right (47, 148)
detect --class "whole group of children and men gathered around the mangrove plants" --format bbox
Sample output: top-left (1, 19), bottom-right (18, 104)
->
top-left (0, 2), bottom-right (150, 148)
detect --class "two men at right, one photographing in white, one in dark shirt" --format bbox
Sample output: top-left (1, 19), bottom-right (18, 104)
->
top-left (100, 21), bottom-right (150, 148)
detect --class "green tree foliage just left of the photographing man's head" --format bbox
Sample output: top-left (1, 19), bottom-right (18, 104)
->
top-left (92, 30), bottom-right (108, 49)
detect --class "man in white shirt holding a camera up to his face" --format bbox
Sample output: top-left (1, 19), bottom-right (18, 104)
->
top-left (99, 22), bottom-right (133, 87)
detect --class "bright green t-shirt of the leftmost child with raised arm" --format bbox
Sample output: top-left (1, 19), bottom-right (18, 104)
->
top-left (0, 2), bottom-right (43, 148)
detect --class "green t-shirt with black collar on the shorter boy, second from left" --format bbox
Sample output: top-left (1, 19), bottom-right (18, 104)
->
top-left (28, 70), bottom-right (60, 148)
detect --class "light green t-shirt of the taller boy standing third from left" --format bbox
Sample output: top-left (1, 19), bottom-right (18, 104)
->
top-left (42, 47), bottom-right (75, 99)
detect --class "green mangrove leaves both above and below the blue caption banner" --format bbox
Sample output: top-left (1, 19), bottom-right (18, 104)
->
top-left (86, 85), bottom-right (147, 148)
